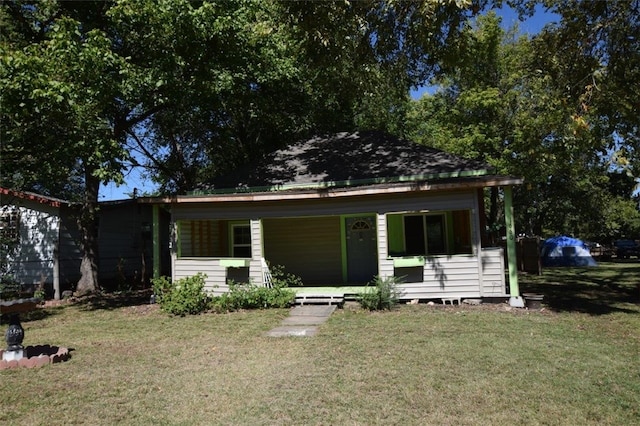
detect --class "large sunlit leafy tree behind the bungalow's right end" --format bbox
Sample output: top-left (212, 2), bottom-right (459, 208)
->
top-left (408, 10), bottom-right (633, 238)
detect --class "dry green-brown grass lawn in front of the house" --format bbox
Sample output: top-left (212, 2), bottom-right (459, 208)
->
top-left (0, 264), bottom-right (640, 425)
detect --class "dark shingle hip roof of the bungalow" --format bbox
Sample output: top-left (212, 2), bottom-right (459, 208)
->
top-left (200, 132), bottom-right (488, 191)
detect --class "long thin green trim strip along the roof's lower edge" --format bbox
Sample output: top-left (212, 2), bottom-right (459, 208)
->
top-left (187, 170), bottom-right (489, 195)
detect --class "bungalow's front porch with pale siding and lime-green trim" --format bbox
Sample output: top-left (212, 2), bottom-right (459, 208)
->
top-left (161, 181), bottom-right (519, 301)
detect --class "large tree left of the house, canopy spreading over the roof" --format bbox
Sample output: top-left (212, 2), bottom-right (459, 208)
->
top-left (0, 0), bottom-right (488, 293)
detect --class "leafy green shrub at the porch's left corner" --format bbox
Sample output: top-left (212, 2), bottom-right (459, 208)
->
top-left (152, 273), bottom-right (210, 316)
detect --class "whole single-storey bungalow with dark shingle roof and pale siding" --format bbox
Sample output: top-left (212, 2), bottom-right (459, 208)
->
top-left (139, 132), bottom-right (522, 306)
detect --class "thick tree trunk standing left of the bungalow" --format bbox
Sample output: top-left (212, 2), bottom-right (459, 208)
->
top-left (76, 170), bottom-right (100, 296)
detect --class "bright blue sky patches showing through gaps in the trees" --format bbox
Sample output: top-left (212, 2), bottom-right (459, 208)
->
top-left (99, 7), bottom-right (555, 201)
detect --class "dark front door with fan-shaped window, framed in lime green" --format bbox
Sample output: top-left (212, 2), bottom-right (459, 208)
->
top-left (345, 216), bottom-right (378, 284)
